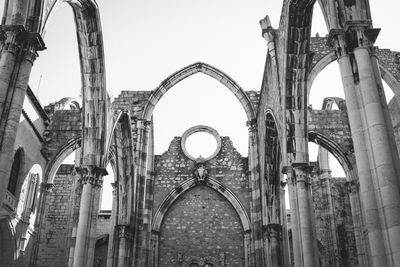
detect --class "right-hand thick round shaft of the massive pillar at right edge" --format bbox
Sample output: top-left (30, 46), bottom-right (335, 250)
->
top-left (354, 41), bottom-right (400, 266)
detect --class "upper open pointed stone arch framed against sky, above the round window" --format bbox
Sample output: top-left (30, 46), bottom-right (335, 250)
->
top-left (142, 62), bottom-right (256, 121)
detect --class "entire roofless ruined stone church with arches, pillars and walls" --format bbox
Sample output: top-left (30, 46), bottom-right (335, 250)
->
top-left (0, 0), bottom-right (400, 267)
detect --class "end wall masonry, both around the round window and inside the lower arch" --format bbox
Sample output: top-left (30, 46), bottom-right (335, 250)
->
top-left (153, 137), bottom-right (250, 267)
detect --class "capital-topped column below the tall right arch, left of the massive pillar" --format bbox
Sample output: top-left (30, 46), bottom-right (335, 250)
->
top-left (292, 163), bottom-right (319, 266)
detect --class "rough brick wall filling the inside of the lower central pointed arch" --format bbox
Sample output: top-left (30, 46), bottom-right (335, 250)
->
top-left (159, 186), bottom-right (244, 267)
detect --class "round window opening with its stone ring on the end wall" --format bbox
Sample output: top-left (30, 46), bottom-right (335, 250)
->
top-left (181, 125), bottom-right (221, 160)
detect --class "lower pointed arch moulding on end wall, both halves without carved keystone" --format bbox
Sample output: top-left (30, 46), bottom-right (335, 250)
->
top-left (152, 178), bottom-right (250, 232)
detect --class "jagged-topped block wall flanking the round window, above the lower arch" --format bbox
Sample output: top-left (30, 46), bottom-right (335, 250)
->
top-left (153, 137), bottom-right (250, 217)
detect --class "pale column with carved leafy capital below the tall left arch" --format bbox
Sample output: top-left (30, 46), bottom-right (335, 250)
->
top-left (73, 166), bottom-right (107, 267)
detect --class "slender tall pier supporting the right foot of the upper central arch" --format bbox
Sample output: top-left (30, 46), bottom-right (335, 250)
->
top-left (247, 121), bottom-right (265, 266)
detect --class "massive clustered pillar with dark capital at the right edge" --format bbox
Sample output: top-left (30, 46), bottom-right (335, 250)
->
top-left (330, 22), bottom-right (400, 266)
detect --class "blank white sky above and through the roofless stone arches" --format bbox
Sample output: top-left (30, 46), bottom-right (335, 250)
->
top-left (0, 0), bottom-right (400, 209)
